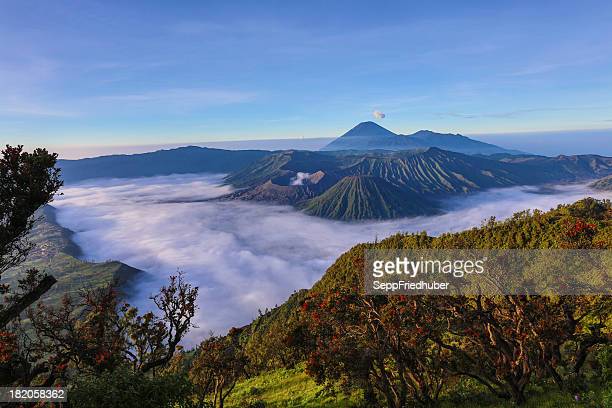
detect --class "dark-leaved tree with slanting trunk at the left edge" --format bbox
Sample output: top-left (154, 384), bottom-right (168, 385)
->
top-left (0, 145), bottom-right (62, 329)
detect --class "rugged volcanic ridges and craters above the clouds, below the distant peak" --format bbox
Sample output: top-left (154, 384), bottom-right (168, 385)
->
top-left (220, 147), bottom-right (612, 221)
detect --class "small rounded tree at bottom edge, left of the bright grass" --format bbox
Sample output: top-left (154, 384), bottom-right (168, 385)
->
top-left (189, 329), bottom-right (247, 408)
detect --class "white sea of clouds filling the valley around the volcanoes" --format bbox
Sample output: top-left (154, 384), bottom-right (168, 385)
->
top-left (53, 175), bottom-right (612, 342)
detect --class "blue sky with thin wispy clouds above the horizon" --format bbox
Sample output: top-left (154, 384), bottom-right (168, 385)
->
top-left (0, 0), bottom-right (612, 151)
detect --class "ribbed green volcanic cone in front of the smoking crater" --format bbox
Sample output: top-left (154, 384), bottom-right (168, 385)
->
top-left (302, 176), bottom-right (437, 221)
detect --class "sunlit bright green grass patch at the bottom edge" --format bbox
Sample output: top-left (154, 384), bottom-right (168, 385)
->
top-left (226, 366), bottom-right (361, 408)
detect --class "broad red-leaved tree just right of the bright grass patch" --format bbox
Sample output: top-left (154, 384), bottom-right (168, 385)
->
top-left (303, 289), bottom-right (450, 408)
